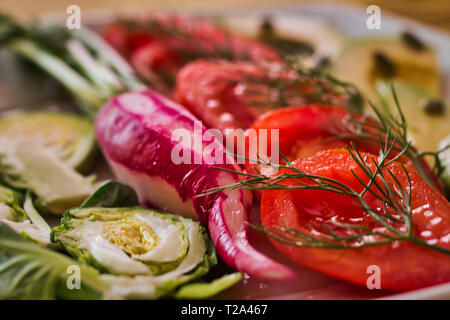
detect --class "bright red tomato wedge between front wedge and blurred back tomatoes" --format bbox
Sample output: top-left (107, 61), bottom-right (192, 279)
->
top-left (245, 105), bottom-right (444, 197)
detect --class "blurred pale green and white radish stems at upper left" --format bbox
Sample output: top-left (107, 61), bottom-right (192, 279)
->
top-left (0, 15), bottom-right (144, 116)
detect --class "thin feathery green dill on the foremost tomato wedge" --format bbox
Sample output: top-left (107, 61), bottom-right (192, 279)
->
top-left (201, 141), bottom-right (450, 255)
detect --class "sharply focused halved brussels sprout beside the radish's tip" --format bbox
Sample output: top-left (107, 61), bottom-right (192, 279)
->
top-left (52, 208), bottom-right (192, 275)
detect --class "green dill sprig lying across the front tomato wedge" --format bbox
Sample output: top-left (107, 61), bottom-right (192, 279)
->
top-left (199, 88), bottom-right (450, 255)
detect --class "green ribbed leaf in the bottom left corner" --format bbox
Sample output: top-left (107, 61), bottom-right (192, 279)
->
top-left (0, 222), bottom-right (105, 299)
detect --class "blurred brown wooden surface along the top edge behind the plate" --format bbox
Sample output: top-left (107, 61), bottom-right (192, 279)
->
top-left (0, 0), bottom-right (450, 32)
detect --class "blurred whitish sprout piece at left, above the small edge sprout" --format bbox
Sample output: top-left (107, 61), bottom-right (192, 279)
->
top-left (0, 137), bottom-right (94, 213)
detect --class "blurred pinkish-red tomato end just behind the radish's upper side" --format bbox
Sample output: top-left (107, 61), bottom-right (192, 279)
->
top-left (174, 60), bottom-right (284, 131)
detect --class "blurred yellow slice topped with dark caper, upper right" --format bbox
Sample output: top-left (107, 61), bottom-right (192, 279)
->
top-left (330, 38), bottom-right (440, 102)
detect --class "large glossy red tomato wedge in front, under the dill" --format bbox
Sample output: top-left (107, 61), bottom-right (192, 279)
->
top-left (261, 149), bottom-right (450, 290)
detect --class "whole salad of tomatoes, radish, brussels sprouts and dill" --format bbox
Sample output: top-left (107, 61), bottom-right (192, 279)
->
top-left (0, 13), bottom-right (450, 299)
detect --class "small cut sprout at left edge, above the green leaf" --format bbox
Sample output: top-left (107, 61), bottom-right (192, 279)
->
top-left (0, 185), bottom-right (50, 246)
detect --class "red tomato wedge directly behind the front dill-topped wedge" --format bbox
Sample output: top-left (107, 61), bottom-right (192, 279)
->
top-left (245, 105), bottom-right (443, 197)
